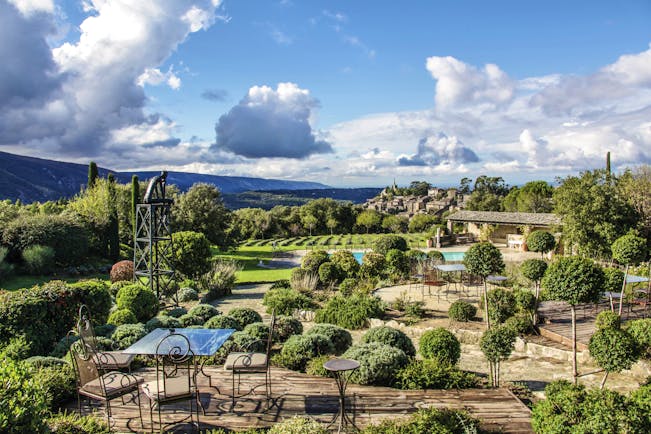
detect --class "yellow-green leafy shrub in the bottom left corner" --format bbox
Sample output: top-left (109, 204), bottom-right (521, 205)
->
top-left (0, 358), bottom-right (48, 434)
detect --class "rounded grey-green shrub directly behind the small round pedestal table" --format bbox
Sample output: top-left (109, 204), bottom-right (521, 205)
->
top-left (342, 342), bottom-right (409, 386)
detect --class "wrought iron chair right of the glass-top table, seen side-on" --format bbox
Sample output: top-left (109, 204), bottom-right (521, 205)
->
top-left (224, 310), bottom-right (276, 408)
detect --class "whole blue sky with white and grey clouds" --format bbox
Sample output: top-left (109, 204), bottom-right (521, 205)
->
top-left (0, 0), bottom-right (651, 187)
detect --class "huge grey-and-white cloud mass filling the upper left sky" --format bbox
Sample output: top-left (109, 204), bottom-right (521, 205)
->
top-left (0, 0), bottom-right (224, 158)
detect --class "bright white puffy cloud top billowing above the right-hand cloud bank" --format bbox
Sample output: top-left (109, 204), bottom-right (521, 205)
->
top-left (425, 56), bottom-right (514, 108)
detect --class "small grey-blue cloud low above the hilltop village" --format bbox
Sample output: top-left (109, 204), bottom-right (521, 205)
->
top-left (397, 133), bottom-right (479, 166)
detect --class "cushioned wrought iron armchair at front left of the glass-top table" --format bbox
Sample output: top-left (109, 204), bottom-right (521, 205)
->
top-left (70, 334), bottom-right (144, 427)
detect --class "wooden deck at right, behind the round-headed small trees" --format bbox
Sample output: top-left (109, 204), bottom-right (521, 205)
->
top-left (538, 301), bottom-right (648, 351)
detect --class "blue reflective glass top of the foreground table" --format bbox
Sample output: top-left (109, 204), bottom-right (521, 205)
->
top-left (122, 328), bottom-right (235, 356)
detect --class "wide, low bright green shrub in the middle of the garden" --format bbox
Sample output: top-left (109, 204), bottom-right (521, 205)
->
top-left (314, 293), bottom-right (384, 329)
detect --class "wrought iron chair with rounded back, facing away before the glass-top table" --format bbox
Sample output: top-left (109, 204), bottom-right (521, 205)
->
top-left (142, 332), bottom-right (201, 432)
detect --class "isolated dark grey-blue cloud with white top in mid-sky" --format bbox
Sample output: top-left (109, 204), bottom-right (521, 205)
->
top-left (215, 83), bottom-right (333, 158)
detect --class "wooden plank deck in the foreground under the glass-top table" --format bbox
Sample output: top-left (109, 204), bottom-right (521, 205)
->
top-left (74, 367), bottom-right (532, 433)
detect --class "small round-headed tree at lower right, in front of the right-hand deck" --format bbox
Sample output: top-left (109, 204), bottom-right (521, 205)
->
top-left (588, 311), bottom-right (639, 389)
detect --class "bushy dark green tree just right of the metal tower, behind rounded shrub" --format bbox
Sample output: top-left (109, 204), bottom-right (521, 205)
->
top-left (172, 183), bottom-right (234, 250)
